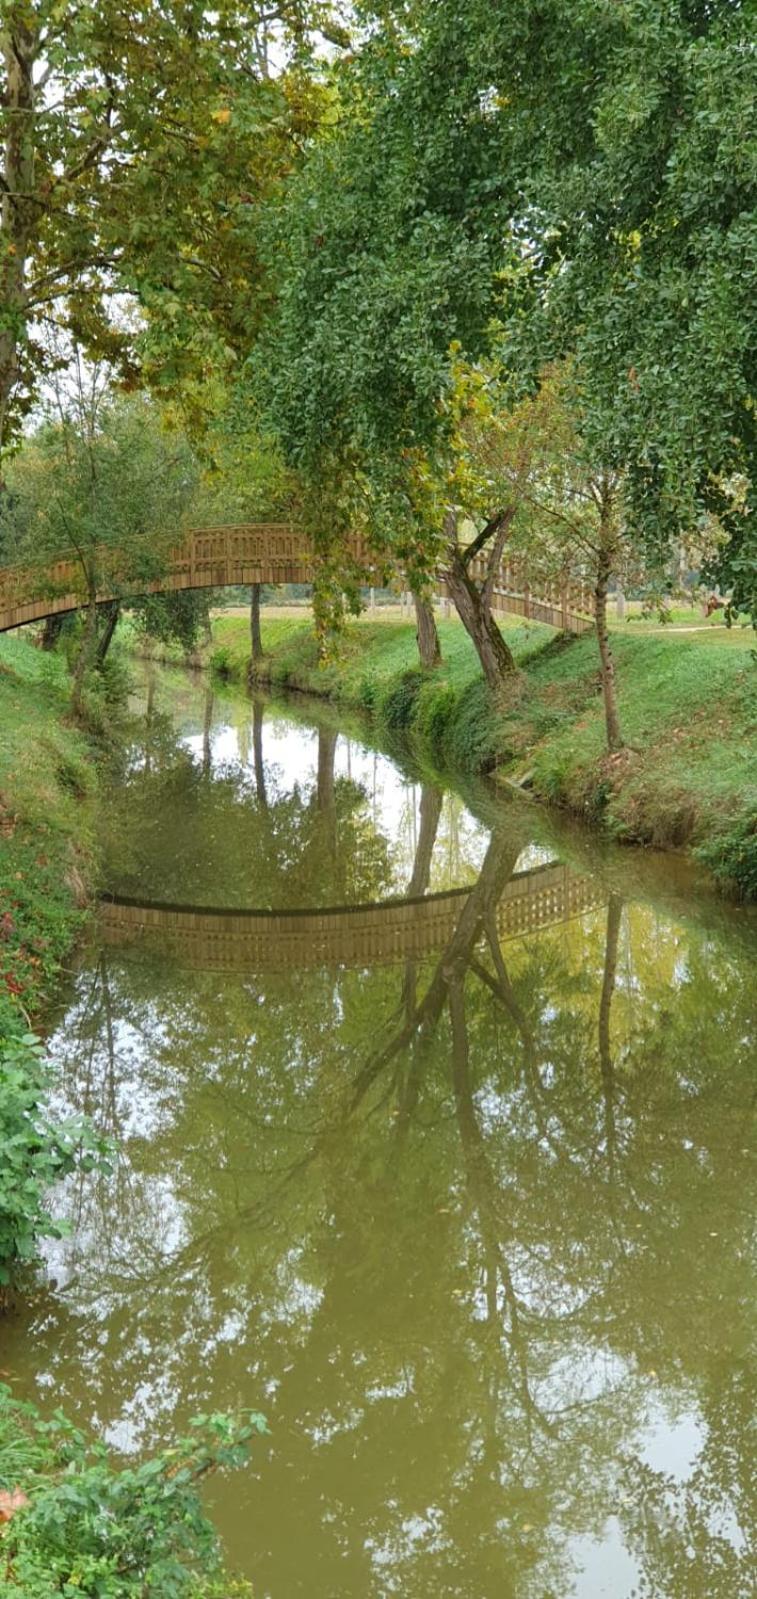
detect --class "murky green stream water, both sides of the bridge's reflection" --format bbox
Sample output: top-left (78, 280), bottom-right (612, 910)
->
top-left (2, 673), bottom-right (757, 1599)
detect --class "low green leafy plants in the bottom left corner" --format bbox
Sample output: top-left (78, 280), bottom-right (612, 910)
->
top-left (0, 1386), bottom-right (267, 1599)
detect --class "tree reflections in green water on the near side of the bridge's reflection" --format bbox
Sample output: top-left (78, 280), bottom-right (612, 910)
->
top-left (14, 825), bottom-right (754, 1599)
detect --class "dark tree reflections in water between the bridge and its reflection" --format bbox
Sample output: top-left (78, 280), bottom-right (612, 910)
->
top-left (106, 703), bottom-right (392, 908)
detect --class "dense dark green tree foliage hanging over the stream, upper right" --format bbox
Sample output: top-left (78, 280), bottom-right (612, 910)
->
top-left (259, 0), bottom-right (757, 608)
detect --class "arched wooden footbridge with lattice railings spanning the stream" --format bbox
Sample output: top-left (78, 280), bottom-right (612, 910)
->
top-left (0, 521), bottom-right (592, 633)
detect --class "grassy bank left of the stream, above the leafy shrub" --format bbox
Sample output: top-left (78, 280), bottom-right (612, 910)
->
top-left (0, 638), bottom-right (96, 1036)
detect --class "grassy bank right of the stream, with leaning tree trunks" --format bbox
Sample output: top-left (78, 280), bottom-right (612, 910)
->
top-left (211, 616), bottom-right (757, 897)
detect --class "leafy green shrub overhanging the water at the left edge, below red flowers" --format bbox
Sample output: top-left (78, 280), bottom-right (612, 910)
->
top-left (0, 1033), bottom-right (109, 1295)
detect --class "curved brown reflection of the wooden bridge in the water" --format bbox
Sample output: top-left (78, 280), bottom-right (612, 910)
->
top-left (99, 862), bottom-right (603, 972)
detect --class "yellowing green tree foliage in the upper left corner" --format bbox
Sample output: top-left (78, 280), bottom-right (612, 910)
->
top-left (0, 0), bottom-right (336, 446)
